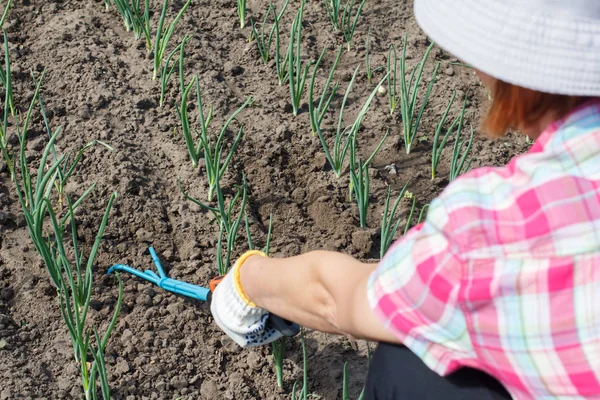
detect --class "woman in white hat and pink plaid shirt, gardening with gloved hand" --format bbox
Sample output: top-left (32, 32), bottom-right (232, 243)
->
top-left (212, 0), bottom-right (600, 399)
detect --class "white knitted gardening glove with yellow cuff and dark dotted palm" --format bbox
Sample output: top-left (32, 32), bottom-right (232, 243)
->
top-left (210, 250), bottom-right (282, 347)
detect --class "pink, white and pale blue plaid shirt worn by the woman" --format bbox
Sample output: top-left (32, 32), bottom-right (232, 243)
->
top-left (368, 102), bottom-right (600, 399)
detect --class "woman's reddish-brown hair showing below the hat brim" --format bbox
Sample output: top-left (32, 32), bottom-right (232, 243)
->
top-left (482, 80), bottom-right (589, 137)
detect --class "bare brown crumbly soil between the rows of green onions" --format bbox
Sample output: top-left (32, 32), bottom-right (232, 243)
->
top-left (0, 0), bottom-right (526, 399)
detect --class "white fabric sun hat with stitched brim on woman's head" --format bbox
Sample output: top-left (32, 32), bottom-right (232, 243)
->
top-left (415, 0), bottom-right (600, 97)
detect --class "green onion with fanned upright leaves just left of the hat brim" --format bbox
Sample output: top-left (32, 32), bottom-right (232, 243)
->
top-left (388, 36), bottom-right (440, 154)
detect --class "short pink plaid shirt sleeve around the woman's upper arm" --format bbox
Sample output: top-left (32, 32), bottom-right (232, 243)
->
top-left (367, 200), bottom-right (473, 375)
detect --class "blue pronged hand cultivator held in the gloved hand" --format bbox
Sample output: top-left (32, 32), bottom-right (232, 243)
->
top-left (108, 247), bottom-right (300, 337)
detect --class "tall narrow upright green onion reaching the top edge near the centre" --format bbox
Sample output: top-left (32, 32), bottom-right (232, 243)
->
top-left (287, 0), bottom-right (311, 116)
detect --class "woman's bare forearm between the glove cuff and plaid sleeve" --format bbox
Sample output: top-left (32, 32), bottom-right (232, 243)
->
top-left (240, 251), bottom-right (398, 343)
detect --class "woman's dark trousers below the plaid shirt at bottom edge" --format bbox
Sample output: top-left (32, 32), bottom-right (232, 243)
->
top-left (365, 343), bottom-right (511, 400)
